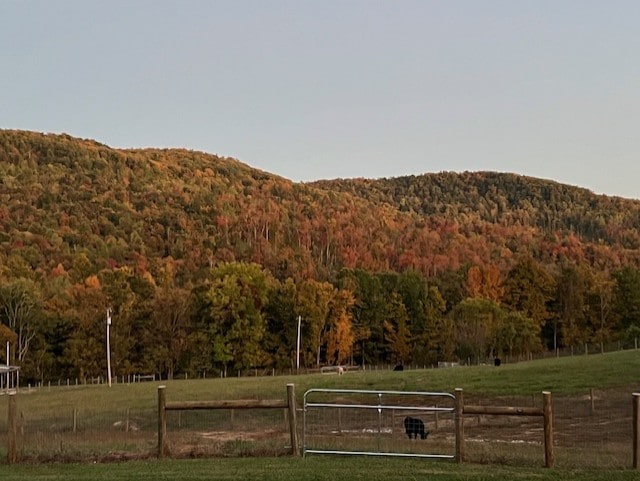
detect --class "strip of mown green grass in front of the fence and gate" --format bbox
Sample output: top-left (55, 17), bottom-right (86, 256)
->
top-left (5, 456), bottom-right (639, 481)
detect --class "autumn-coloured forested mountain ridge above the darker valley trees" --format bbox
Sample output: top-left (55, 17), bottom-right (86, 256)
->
top-left (0, 130), bottom-right (640, 284)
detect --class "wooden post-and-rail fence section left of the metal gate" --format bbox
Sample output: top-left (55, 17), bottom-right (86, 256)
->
top-left (158, 384), bottom-right (299, 458)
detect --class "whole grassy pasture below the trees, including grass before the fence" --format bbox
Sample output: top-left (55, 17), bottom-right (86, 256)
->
top-left (0, 351), bottom-right (640, 480)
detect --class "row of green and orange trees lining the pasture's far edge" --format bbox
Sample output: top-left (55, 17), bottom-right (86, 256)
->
top-left (0, 258), bottom-right (640, 381)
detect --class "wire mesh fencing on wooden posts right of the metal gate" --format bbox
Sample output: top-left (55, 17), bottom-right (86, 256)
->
top-left (452, 390), bottom-right (633, 469)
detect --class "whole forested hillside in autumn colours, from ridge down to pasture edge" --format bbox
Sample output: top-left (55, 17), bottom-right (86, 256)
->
top-left (0, 130), bottom-right (640, 380)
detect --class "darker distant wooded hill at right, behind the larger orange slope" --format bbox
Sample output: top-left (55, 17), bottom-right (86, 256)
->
top-left (313, 172), bottom-right (640, 249)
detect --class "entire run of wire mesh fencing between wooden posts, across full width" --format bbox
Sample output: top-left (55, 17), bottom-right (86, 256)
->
top-left (0, 380), bottom-right (633, 469)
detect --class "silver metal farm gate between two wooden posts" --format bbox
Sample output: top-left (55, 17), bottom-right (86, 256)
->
top-left (302, 389), bottom-right (456, 459)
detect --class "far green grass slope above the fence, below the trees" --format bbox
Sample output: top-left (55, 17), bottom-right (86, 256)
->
top-left (8, 350), bottom-right (640, 419)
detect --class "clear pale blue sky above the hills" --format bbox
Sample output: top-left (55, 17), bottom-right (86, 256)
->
top-left (0, 0), bottom-right (640, 198)
